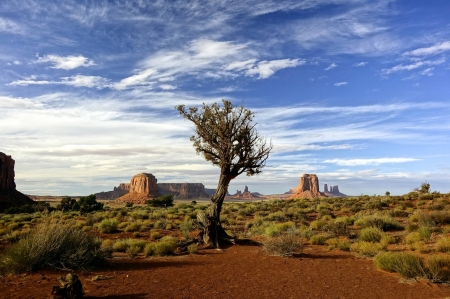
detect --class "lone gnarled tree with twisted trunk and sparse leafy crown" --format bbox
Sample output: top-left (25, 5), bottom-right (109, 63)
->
top-left (175, 100), bottom-right (273, 247)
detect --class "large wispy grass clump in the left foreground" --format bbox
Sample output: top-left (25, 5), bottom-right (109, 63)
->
top-left (0, 224), bottom-right (105, 274)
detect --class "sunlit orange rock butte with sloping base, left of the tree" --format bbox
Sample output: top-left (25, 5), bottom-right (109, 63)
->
top-left (117, 173), bottom-right (159, 204)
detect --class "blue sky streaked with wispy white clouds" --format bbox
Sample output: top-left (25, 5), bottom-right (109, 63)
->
top-left (0, 0), bottom-right (450, 195)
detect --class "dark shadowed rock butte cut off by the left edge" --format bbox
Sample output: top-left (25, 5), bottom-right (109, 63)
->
top-left (0, 152), bottom-right (34, 212)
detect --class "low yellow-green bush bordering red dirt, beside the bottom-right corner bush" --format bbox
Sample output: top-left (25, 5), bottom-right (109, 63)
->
top-left (374, 252), bottom-right (426, 278)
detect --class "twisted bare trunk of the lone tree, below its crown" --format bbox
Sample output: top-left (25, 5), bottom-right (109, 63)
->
top-left (203, 174), bottom-right (234, 248)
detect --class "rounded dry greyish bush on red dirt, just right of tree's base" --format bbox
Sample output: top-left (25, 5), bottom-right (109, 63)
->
top-left (263, 234), bottom-right (303, 256)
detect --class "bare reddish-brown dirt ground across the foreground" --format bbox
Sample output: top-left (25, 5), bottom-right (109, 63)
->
top-left (0, 245), bottom-right (450, 299)
